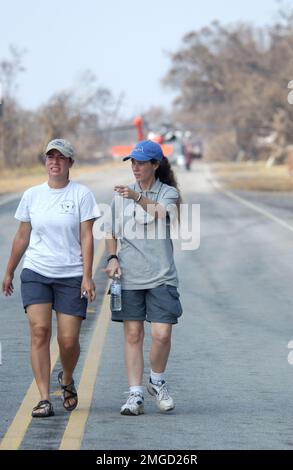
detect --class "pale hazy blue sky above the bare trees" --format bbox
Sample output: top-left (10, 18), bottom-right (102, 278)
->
top-left (0, 0), bottom-right (286, 116)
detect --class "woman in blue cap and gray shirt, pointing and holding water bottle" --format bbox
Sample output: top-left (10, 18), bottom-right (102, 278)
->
top-left (106, 141), bottom-right (182, 415)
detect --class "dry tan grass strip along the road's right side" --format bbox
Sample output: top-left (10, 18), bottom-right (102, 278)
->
top-left (210, 162), bottom-right (293, 192)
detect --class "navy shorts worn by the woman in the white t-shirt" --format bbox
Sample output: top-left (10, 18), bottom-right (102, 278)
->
top-left (20, 268), bottom-right (87, 319)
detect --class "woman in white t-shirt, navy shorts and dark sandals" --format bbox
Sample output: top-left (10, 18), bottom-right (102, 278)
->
top-left (2, 139), bottom-right (99, 418)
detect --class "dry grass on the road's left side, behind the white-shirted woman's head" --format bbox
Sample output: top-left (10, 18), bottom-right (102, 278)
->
top-left (0, 161), bottom-right (121, 195)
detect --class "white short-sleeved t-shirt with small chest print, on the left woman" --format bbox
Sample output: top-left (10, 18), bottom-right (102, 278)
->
top-left (15, 181), bottom-right (100, 278)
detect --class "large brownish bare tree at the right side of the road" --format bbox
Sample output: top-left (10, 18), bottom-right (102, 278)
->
top-left (164, 6), bottom-right (293, 158)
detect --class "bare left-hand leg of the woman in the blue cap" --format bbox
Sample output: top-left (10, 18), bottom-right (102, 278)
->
top-left (124, 320), bottom-right (144, 387)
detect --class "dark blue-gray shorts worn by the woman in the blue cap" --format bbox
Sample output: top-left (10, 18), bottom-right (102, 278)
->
top-left (112, 284), bottom-right (182, 324)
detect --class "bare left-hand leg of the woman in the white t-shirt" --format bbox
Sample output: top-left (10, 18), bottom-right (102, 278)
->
top-left (26, 304), bottom-right (52, 400)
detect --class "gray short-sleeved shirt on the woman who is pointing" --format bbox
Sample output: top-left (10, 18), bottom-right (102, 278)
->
top-left (105, 180), bottom-right (179, 290)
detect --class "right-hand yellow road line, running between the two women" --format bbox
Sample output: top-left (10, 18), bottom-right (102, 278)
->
top-left (59, 289), bottom-right (110, 450)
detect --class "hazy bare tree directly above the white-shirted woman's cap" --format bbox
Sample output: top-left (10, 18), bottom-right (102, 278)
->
top-left (39, 70), bottom-right (122, 160)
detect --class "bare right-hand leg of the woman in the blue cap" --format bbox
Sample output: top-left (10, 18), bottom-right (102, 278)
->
top-left (150, 323), bottom-right (172, 373)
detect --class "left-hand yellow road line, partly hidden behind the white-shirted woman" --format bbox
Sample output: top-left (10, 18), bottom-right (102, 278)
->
top-left (0, 240), bottom-right (105, 450)
